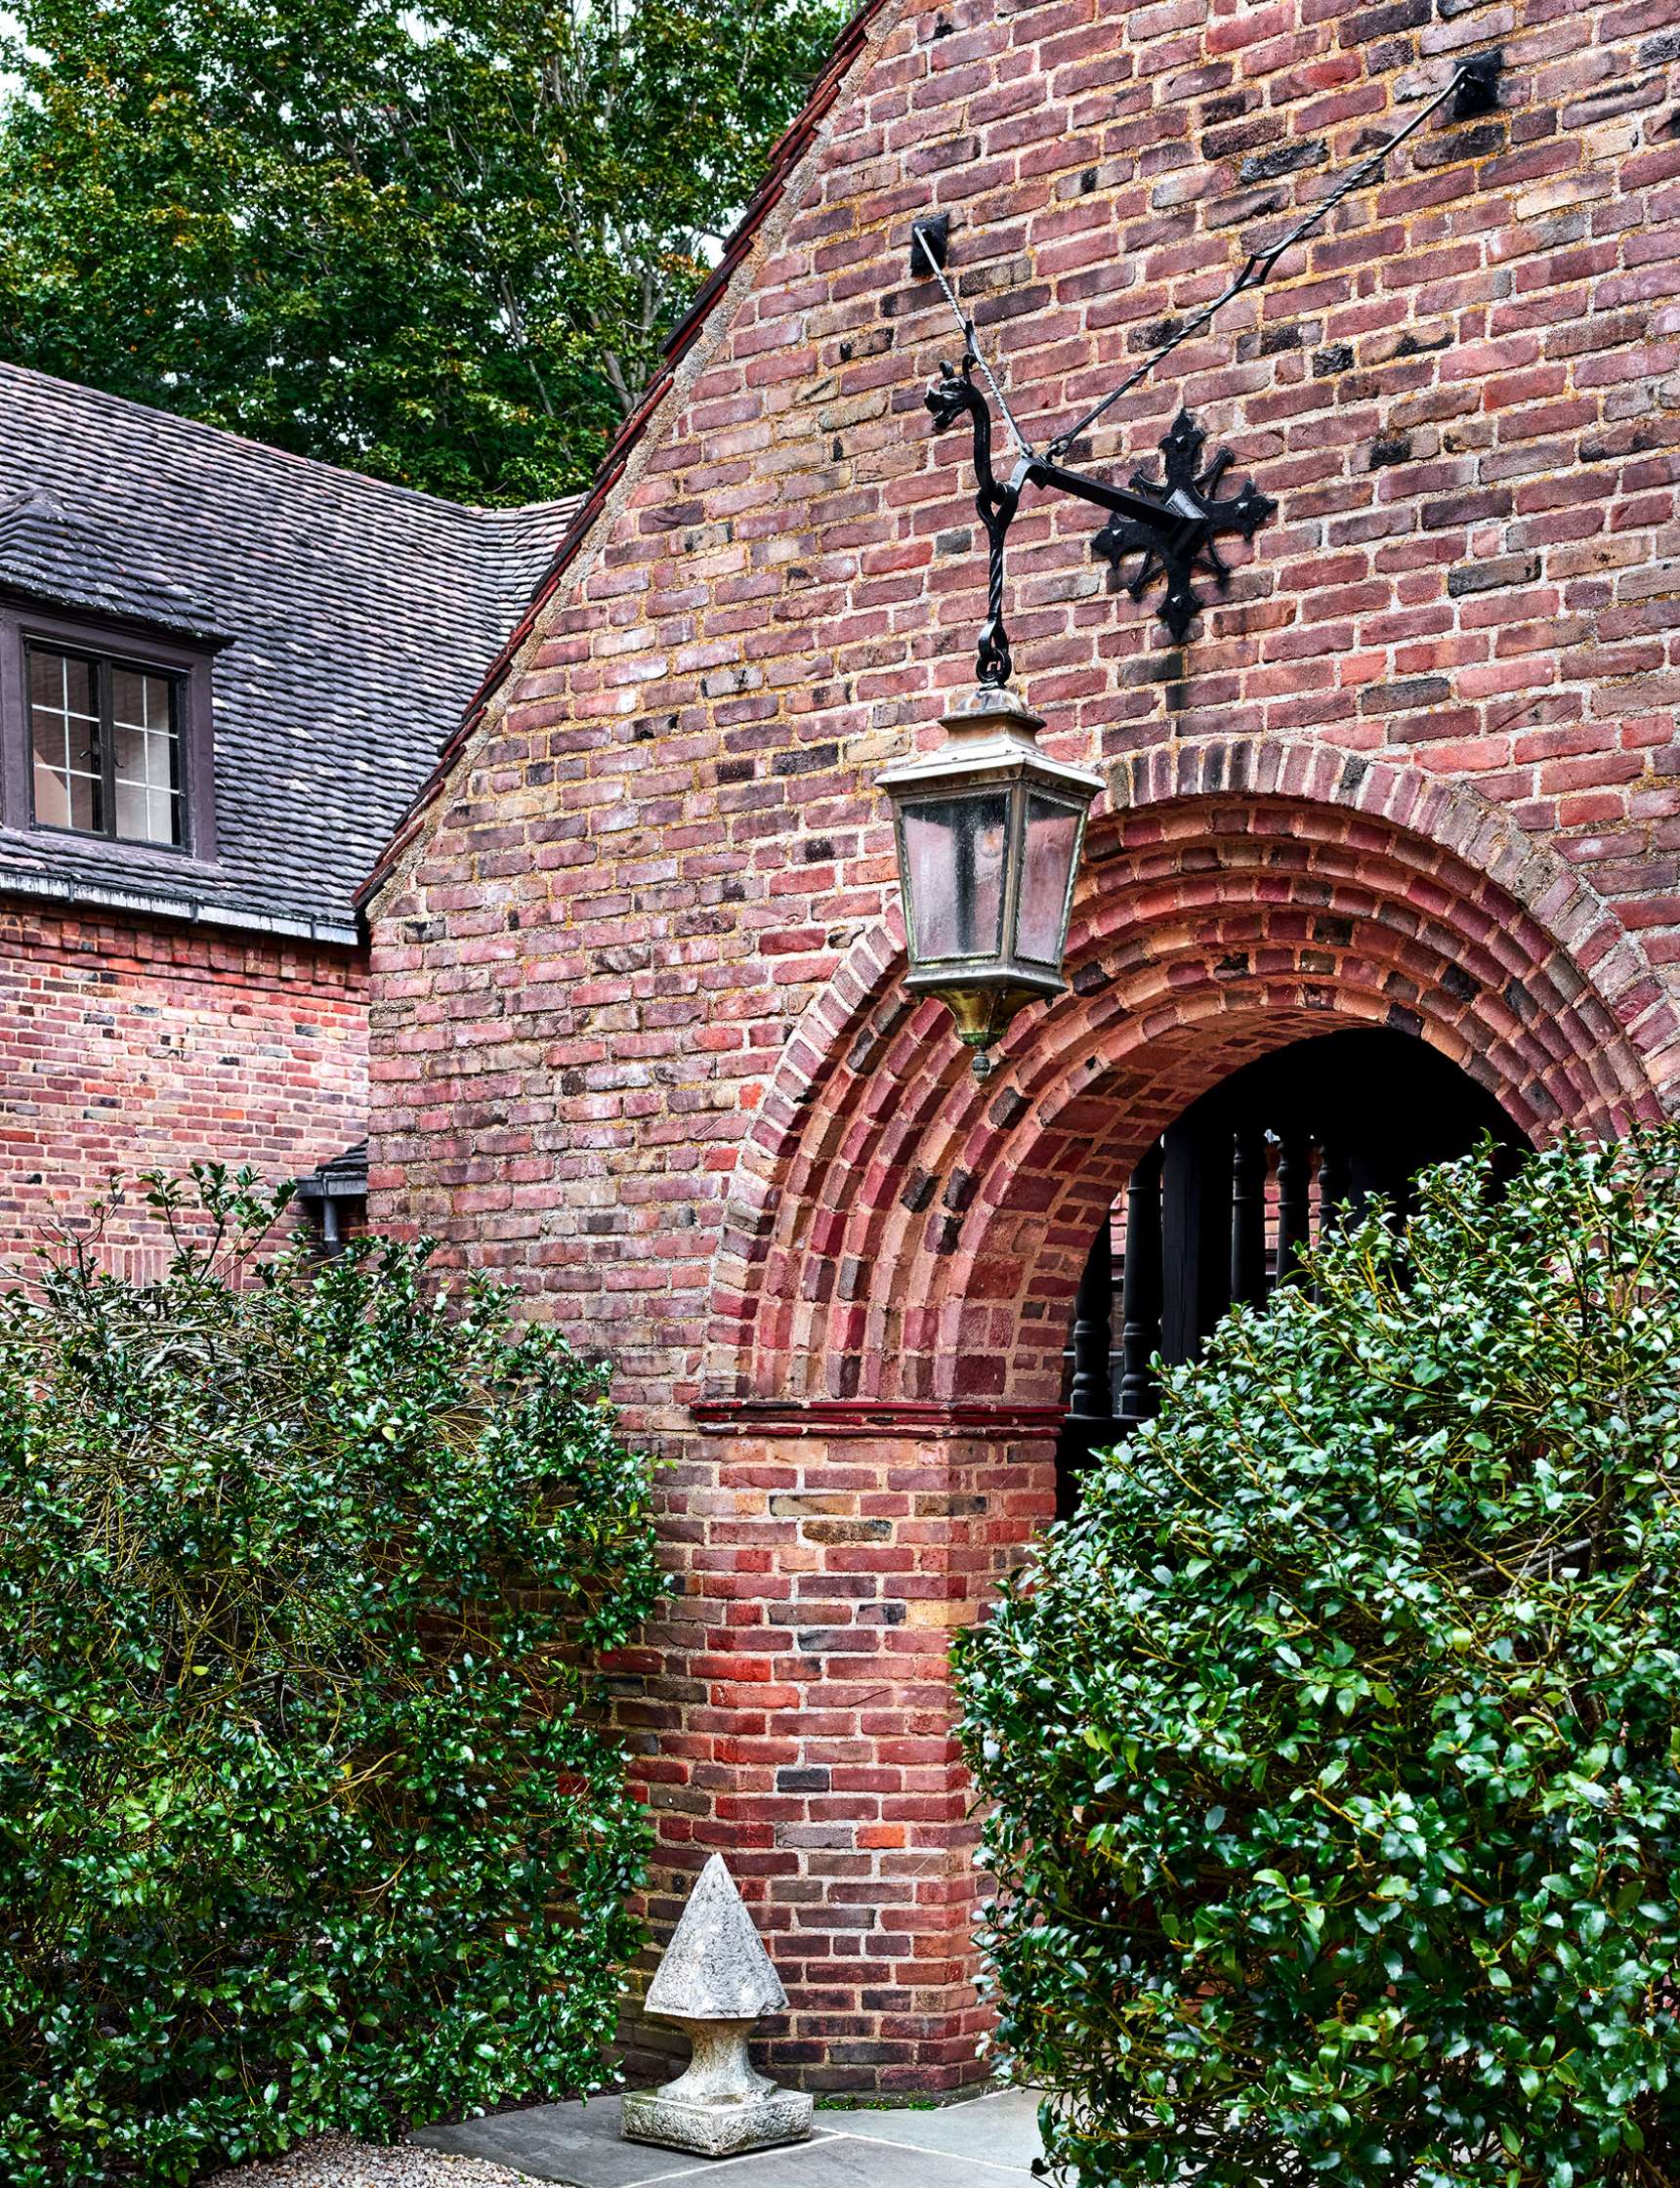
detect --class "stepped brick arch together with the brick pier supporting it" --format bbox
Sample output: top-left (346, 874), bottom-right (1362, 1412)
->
top-left (687, 778), bottom-right (1680, 2087)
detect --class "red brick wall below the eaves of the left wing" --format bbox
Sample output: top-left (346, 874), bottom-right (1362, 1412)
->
top-left (0, 904), bottom-right (367, 1276)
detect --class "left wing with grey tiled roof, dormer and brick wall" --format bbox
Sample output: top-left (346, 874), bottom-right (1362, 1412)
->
top-left (0, 365), bottom-right (571, 1271)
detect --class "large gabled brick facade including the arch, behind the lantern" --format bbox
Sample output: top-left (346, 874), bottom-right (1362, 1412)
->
top-left (367, 0), bottom-right (1680, 2085)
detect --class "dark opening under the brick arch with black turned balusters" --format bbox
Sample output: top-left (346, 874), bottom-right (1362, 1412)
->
top-left (1057, 1029), bottom-right (1529, 1514)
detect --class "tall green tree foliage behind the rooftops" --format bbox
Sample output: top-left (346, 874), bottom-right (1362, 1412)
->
top-left (0, 0), bottom-right (844, 501)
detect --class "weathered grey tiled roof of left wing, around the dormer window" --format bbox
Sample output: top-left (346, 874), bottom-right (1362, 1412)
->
top-left (0, 365), bottom-right (582, 937)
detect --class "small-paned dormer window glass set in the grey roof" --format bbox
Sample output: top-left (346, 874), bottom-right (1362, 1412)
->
top-left (26, 639), bottom-right (186, 849)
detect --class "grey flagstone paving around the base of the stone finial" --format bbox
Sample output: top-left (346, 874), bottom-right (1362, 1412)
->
top-left (413, 2089), bottom-right (1043, 2188)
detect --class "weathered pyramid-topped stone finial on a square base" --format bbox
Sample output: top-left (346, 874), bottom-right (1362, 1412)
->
top-left (623, 1853), bottom-right (812, 2158)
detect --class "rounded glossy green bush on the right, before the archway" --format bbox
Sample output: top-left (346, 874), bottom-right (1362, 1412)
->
top-left (958, 1127), bottom-right (1680, 2188)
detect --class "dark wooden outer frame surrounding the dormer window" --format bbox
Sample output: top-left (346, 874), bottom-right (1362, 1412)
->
top-left (0, 604), bottom-right (217, 873)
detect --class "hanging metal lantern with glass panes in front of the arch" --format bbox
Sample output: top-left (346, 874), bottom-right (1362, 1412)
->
top-left (875, 685), bottom-right (1103, 1078)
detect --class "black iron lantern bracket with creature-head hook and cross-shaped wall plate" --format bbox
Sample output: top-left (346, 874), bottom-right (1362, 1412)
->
top-left (928, 350), bottom-right (1278, 687)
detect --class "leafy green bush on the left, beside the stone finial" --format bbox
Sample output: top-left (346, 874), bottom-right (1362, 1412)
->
top-left (0, 1170), bottom-right (658, 2188)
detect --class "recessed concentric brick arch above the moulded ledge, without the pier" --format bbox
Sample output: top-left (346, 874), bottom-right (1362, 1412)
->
top-left (706, 741), bottom-right (1676, 1407)
